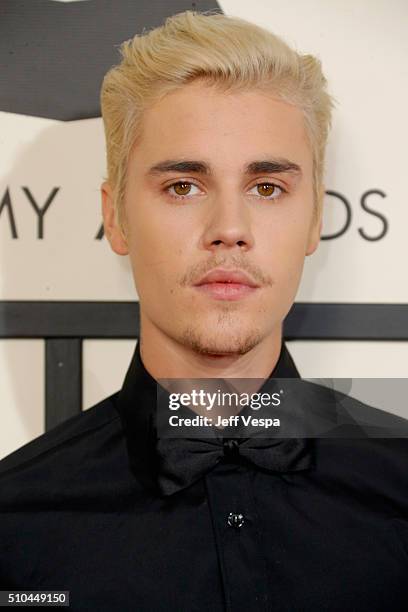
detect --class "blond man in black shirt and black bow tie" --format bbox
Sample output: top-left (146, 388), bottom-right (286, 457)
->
top-left (0, 12), bottom-right (408, 612)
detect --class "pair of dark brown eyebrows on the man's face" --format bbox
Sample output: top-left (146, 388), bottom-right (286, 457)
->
top-left (147, 158), bottom-right (302, 175)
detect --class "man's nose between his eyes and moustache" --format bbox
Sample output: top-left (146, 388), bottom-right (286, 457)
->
top-left (202, 190), bottom-right (254, 252)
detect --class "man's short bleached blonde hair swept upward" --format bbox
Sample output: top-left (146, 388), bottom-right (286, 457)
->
top-left (101, 11), bottom-right (334, 231)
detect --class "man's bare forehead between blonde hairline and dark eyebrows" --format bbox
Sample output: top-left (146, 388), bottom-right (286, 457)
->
top-left (133, 82), bottom-right (311, 167)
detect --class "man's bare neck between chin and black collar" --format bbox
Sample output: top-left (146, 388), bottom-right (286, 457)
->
top-left (140, 317), bottom-right (282, 380)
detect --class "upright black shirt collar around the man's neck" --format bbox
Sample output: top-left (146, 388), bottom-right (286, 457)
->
top-left (116, 341), bottom-right (300, 487)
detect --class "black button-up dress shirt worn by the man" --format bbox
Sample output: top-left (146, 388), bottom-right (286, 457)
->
top-left (0, 343), bottom-right (408, 612)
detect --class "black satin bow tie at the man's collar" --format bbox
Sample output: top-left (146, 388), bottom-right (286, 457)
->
top-left (156, 437), bottom-right (312, 495)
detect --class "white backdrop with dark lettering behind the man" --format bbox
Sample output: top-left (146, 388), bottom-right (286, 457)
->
top-left (0, 0), bottom-right (408, 456)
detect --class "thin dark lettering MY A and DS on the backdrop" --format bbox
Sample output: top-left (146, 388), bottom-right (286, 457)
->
top-left (0, 187), bottom-right (389, 242)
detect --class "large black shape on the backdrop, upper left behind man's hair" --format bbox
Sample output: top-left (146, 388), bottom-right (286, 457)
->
top-left (0, 0), bottom-right (222, 121)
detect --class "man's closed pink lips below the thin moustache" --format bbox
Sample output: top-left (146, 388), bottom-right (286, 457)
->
top-left (194, 268), bottom-right (259, 300)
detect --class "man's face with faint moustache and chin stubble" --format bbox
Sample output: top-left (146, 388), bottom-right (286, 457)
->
top-left (104, 81), bottom-right (320, 354)
